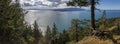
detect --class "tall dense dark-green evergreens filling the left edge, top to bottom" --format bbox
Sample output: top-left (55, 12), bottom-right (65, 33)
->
top-left (0, 0), bottom-right (25, 44)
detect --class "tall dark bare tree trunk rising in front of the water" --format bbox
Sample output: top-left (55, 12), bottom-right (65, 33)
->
top-left (91, 0), bottom-right (95, 30)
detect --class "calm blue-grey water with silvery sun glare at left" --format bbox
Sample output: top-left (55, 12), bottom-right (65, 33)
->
top-left (25, 10), bottom-right (120, 31)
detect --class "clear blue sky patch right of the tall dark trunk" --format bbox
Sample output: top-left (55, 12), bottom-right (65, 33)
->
top-left (97, 0), bottom-right (120, 10)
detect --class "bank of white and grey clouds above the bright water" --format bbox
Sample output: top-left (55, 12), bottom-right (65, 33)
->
top-left (20, 0), bottom-right (69, 8)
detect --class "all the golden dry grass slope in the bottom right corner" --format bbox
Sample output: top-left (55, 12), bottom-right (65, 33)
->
top-left (77, 26), bottom-right (120, 44)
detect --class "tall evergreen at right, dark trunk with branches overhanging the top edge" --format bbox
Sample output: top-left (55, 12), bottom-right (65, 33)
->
top-left (67, 0), bottom-right (99, 30)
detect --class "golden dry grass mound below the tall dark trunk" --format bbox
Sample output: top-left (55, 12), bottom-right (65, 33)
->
top-left (78, 36), bottom-right (113, 44)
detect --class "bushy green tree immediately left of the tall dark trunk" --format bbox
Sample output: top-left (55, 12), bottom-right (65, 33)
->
top-left (68, 19), bottom-right (89, 42)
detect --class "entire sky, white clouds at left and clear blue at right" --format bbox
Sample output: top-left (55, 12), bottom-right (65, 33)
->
top-left (20, 0), bottom-right (120, 10)
